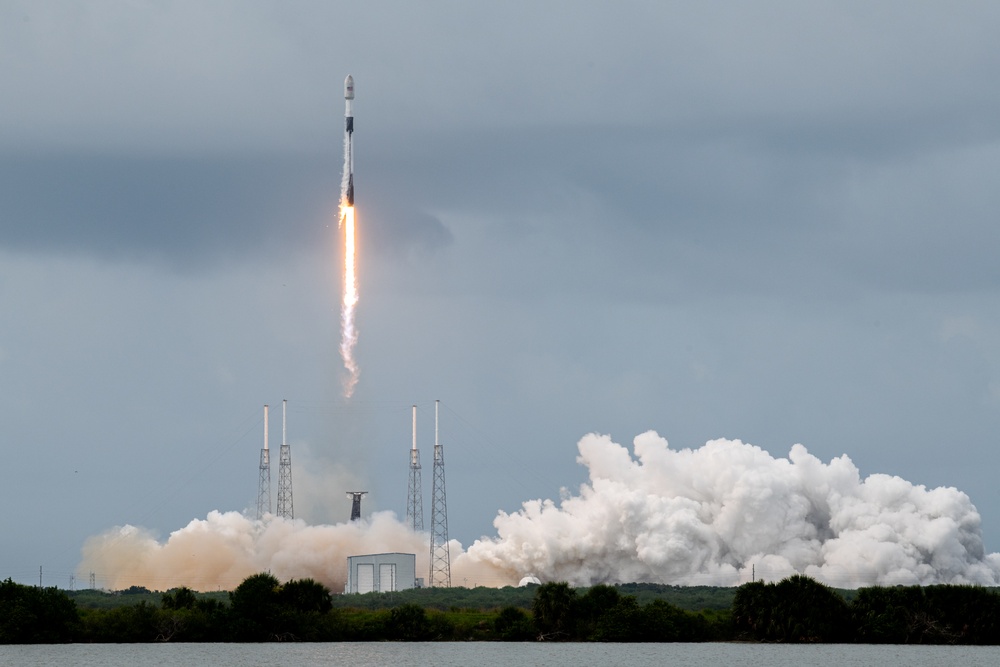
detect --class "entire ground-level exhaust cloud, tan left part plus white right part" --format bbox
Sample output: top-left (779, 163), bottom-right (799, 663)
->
top-left (79, 432), bottom-right (1000, 592)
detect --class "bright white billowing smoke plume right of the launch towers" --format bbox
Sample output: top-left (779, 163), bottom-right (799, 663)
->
top-left (465, 432), bottom-right (1000, 588)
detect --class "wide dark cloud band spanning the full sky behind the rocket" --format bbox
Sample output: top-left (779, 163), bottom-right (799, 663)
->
top-left (7, 88), bottom-right (1000, 296)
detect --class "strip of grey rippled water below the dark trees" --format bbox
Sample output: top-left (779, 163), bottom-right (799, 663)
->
top-left (0, 642), bottom-right (1000, 667)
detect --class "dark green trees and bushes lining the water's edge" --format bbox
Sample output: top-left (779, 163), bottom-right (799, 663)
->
top-left (0, 573), bottom-right (1000, 644)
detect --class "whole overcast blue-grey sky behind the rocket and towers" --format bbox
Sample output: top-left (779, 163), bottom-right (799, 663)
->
top-left (0, 0), bottom-right (1000, 587)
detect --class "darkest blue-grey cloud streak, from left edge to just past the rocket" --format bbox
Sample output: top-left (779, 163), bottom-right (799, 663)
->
top-left (0, 155), bottom-right (448, 267)
